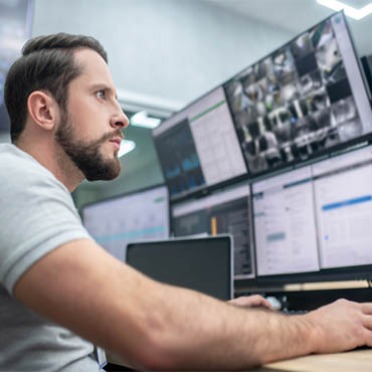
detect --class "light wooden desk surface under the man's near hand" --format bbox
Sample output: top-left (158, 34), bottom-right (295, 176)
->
top-left (253, 349), bottom-right (372, 372)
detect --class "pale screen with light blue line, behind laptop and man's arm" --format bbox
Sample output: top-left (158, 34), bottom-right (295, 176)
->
top-left (82, 185), bottom-right (170, 261)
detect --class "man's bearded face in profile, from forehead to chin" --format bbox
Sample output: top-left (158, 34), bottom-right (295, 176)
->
top-left (56, 49), bottom-right (128, 181)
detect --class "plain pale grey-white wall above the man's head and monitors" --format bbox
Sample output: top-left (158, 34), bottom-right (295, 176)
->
top-left (33, 0), bottom-right (293, 105)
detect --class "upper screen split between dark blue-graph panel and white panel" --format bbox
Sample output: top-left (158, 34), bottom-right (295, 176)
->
top-left (152, 87), bottom-right (247, 200)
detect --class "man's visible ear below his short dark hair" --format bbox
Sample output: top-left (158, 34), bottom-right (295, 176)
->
top-left (27, 90), bottom-right (59, 131)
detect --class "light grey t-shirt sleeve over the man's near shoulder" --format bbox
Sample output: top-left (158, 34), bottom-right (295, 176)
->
top-left (0, 147), bottom-right (90, 293)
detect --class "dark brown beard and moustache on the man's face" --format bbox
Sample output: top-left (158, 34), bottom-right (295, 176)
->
top-left (56, 110), bottom-right (121, 181)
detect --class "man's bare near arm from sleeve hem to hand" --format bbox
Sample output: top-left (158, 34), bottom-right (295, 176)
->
top-left (15, 240), bottom-right (372, 370)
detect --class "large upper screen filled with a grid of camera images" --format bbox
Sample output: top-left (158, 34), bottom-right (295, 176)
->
top-left (224, 12), bottom-right (372, 177)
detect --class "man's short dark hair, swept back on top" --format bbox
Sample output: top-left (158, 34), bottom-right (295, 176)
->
top-left (4, 33), bottom-right (108, 142)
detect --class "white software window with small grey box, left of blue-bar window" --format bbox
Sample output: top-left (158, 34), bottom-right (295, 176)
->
top-left (252, 167), bottom-right (319, 275)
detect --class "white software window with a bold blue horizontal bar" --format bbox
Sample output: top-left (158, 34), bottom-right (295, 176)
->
top-left (313, 146), bottom-right (372, 269)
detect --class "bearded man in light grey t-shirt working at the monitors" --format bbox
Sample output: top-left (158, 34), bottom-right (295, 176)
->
top-left (0, 34), bottom-right (372, 371)
